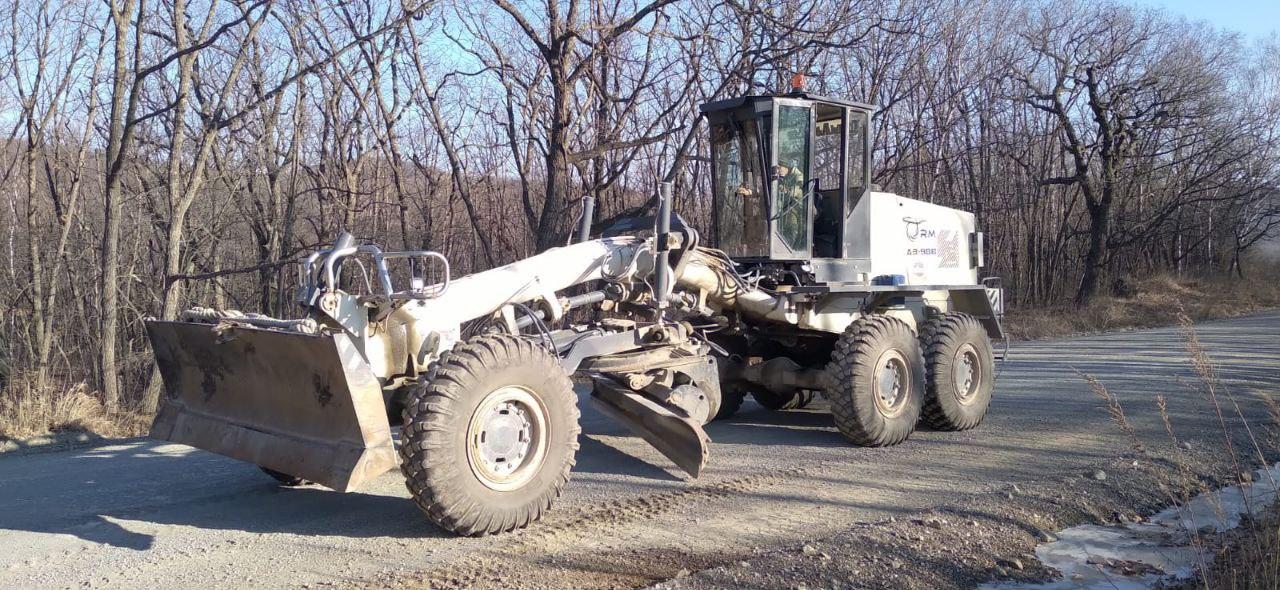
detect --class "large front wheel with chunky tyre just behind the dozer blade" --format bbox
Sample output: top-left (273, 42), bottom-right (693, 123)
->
top-left (401, 334), bottom-right (581, 536)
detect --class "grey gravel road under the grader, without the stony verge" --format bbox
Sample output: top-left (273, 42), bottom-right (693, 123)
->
top-left (0, 312), bottom-right (1280, 589)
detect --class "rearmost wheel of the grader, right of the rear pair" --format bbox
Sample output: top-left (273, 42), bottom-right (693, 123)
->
top-left (920, 314), bottom-right (996, 430)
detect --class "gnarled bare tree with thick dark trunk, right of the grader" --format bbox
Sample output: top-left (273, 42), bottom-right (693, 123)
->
top-left (1014, 5), bottom-right (1215, 305)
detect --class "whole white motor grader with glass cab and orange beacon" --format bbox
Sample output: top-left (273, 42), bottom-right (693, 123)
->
top-left (146, 90), bottom-right (1004, 535)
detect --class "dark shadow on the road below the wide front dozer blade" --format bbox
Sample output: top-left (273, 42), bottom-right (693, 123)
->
top-left (0, 442), bottom-right (449, 550)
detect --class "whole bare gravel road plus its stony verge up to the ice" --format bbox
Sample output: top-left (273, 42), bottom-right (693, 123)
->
top-left (0, 312), bottom-right (1280, 589)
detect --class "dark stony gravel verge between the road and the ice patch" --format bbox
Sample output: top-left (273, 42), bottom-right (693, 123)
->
top-left (654, 453), bottom-right (1259, 589)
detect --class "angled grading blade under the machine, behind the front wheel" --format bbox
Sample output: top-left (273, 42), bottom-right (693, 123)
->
top-left (591, 378), bottom-right (712, 477)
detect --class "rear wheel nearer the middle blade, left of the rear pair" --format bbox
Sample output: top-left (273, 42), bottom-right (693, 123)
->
top-left (823, 315), bottom-right (924, 447)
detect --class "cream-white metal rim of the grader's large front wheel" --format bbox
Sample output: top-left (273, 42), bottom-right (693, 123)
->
top-left (467, 385), bottom-right (547, 491)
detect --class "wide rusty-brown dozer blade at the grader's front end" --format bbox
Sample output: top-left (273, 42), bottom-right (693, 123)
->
top-left (146, 320), bottom-right (397, 491)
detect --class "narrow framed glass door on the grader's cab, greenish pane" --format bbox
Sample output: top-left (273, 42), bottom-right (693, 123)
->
top-left (769, 99), bottom-right (813, 260)
